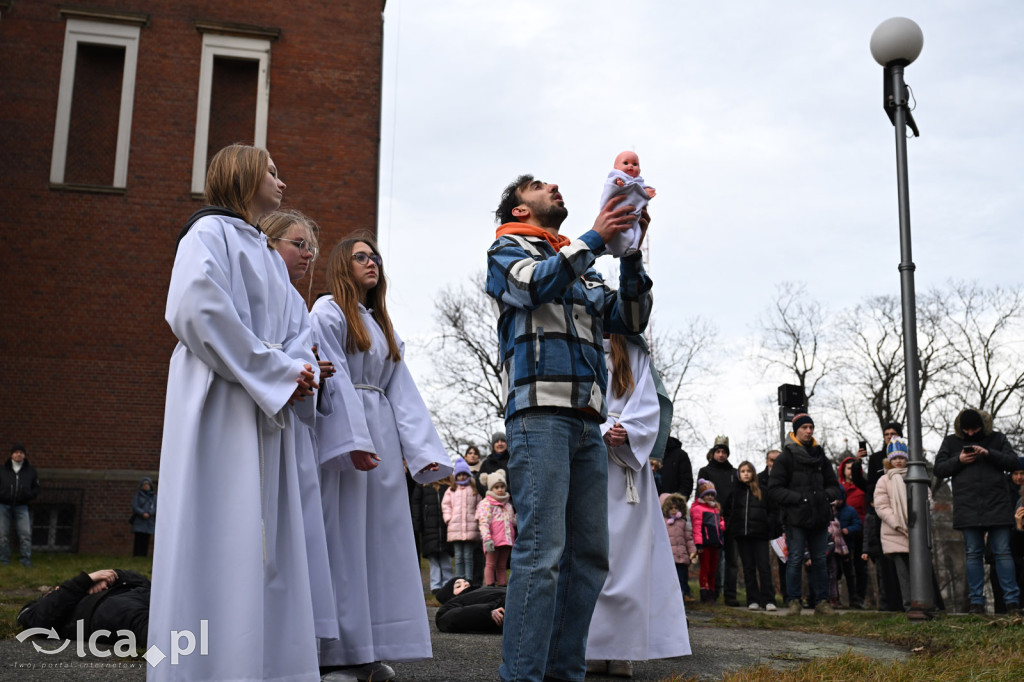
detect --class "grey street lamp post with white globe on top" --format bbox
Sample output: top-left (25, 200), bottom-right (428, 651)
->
top-left (871, 16), bottom-right (934, 621)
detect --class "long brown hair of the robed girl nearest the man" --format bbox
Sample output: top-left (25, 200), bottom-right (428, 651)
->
top-left (327, 237), bottom-right (401, 363)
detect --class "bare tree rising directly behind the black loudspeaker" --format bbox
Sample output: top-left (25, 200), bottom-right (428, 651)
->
top-left (756, 282), bottom-right (837, 401)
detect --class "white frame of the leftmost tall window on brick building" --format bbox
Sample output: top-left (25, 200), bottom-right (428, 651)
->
top-left (50, 17), bottom-right (140, 189)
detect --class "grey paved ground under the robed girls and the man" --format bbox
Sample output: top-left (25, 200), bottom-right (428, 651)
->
top-left (0, 608), bottom-right (908, 682)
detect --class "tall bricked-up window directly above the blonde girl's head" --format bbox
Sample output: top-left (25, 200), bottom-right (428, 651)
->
top-left (191, 29), bottom-right (278, 195)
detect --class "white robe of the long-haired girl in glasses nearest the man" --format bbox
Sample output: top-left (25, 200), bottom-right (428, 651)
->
top-left (310, 296), bottom-right (453, 666)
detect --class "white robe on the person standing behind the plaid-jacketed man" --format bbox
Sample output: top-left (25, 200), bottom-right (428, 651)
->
top-left (587, 341), bottom-right (690, 660)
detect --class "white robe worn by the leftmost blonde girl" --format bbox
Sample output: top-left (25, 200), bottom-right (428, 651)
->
top-left (147, 217), bottom-right (319, 681)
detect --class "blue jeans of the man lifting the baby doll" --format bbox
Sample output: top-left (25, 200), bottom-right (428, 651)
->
top-left (499, 414), bottom-right (608, 682)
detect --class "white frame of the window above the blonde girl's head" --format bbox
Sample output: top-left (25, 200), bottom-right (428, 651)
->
top-left (191, 33), bottom-right (270, 195)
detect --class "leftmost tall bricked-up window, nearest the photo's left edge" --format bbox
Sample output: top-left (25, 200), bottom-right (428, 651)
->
top-left (50, 9), bottom-right (148, 189)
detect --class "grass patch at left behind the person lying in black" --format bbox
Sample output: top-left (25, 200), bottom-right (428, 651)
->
top-left (0, 552), bottom-right (153, 639)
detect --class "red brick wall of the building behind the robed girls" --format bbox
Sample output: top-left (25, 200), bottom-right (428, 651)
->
top-left (0, 0), bottom-right (383, 552)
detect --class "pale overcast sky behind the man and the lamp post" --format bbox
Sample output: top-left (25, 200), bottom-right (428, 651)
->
top-left (379, 0), bottom-right (1024, 461)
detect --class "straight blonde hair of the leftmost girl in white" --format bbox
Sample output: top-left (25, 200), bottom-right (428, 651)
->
top-left (204, 144), bottom-right (270, 225)
